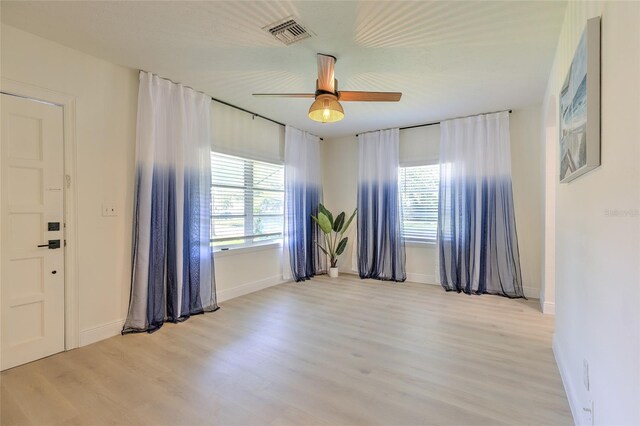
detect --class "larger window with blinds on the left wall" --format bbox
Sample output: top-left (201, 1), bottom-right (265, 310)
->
top-left (211, 152), bottom-right (284, 248)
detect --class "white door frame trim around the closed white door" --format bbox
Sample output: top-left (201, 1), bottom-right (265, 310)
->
top-left (0, 77), bottom-right (80, 351)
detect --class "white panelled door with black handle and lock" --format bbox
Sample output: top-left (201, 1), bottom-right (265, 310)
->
top-left (0, 94), bottom-right (64, 370)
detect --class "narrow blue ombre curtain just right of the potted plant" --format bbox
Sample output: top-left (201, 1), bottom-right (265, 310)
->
top-left (357, 129), bottom-right (407, 281)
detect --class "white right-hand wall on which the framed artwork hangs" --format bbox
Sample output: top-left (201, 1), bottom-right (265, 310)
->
top-left (543, 2), bottom-right (640, 425)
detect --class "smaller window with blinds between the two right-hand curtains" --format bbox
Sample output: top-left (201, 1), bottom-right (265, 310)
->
top-left (399, 164), bottom-right (440, 242)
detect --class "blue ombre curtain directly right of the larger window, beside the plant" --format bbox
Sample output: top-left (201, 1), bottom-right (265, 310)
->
top-left (283, 126), bottom-right (326, 281)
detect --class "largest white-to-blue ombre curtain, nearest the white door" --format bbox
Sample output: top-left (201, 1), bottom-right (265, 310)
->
top-left (123, 72), bottom-right (218, 333)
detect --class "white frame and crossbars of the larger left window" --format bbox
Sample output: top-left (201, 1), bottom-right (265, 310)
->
top-left (210, 149), bottom-right (284, 250)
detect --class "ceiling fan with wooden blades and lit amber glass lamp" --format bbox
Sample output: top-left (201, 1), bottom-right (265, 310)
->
top-left (253, 53), bottom-right (402, 123)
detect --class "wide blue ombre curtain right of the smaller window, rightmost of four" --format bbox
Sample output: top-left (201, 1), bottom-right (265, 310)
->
top-left (438, 112), bottom-right (524, 297)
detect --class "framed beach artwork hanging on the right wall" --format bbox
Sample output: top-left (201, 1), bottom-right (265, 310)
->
top-left (560, 17), bottom-right (600, 183)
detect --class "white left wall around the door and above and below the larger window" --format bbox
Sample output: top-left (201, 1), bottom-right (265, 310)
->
top-left (1, 24), bottom-right (284, 345)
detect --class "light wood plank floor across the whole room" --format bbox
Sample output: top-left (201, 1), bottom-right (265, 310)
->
top-left (0, 276), bottom-right (572, 425)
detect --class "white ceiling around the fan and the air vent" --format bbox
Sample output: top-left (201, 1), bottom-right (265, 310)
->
top-left (1, 0), bottom-right (566, 137)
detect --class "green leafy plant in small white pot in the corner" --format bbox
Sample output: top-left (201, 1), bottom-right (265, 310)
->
top-left (311, 204), bottom-right (358, 278)
